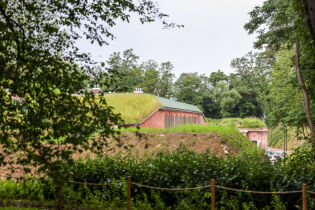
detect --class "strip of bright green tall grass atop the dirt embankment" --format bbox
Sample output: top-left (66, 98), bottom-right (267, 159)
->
top-left (121, 123), bottom-right (238, 134)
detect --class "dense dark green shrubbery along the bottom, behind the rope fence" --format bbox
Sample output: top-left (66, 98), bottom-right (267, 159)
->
top-left (0, 148), bottom-right (315, 209)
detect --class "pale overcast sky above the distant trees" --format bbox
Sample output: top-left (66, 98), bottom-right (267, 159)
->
top-left (79, 0), bottom-right (262, 77)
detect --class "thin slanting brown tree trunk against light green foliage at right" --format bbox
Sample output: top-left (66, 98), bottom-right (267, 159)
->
top-left (295, 39), bottom-right (315, 149)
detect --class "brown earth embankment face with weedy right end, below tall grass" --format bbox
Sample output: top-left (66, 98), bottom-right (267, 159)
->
top-left (101, 132), bottom-right (252, 156)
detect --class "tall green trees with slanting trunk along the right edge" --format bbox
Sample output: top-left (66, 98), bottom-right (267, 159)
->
top-left (244, 0), bottom-right (315, 149)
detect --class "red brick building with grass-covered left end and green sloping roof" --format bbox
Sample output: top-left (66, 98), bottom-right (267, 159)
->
top-left (105, 93), bottom-right (207, 128)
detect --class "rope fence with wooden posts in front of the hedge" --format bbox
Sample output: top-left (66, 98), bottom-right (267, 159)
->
top-left (70, 176), bottom-right (315, 210)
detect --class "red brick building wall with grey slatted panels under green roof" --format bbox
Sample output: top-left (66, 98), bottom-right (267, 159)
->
top-left (140, 110), bottom-right (207, 128)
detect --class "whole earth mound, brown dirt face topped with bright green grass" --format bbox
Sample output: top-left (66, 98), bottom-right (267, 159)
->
top-left (100, 123), bottom-right (259, 156)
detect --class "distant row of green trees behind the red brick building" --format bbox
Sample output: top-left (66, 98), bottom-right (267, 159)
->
top-left (101, 49), bottom-right (263, 118)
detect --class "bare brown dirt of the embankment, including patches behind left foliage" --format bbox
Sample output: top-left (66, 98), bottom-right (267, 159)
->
top-left (0, 133), bottom-right (238, 180)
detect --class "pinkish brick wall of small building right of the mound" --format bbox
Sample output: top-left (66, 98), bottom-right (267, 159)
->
top-left (239, 127), bottom-right (268, 149)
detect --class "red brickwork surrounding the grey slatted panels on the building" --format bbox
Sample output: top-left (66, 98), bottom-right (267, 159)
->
top-left (140, 110), bottom-right (207, 128)
